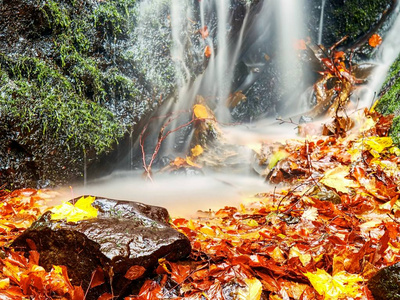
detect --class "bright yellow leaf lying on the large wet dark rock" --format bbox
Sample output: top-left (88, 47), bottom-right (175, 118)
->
top-left (51, 196), bottom-right (98, 222)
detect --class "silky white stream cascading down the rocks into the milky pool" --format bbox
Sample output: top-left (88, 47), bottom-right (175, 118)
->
top-left (61, 0), bottom-right (400, 217)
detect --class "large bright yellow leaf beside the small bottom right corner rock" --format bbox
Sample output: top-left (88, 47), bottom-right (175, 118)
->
top-left (304, 269), bottom-right (363, 300)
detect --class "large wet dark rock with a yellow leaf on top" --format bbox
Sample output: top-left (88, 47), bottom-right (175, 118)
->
top-left (11, 198), bottom-right (191, 300)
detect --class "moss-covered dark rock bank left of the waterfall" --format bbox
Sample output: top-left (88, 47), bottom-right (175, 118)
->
top-left (0, 0), bottom-right (153, 188)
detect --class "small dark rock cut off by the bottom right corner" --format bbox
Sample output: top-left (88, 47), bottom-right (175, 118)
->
top-left (368, 263), bottom-right (400, 300)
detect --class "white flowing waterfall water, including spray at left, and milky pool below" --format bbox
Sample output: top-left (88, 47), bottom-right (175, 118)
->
top-left (65, 0), bottom-right (400, 216)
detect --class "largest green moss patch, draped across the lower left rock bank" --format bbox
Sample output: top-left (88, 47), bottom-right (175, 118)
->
top-left (0, 56), bottom-right (123, 153)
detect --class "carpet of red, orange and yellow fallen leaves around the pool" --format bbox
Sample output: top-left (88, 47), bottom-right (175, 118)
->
top-left (0, 108), bottom-right (400, 300)
